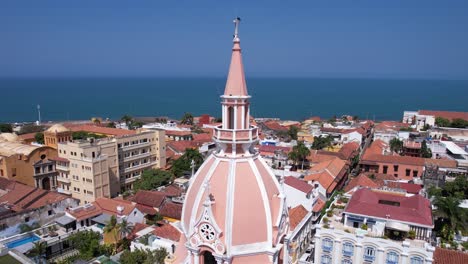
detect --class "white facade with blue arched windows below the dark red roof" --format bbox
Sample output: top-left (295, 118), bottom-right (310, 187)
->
top-left (313, 225), bottom-right (435, 264)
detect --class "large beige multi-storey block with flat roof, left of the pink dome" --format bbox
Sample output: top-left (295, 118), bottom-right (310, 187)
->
top-left (56, 131), bottom-right (166, 204)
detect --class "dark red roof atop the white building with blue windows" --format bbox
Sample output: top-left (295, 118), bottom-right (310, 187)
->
top-left (345, 188), bottom-right (433, 226)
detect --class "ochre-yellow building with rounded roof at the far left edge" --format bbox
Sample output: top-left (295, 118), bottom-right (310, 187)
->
top-left (0, 133), bottom-right (57, 187)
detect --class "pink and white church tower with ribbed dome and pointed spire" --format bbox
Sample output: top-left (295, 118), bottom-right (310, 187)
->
top-left (175, 18), bottom-right (289, 264)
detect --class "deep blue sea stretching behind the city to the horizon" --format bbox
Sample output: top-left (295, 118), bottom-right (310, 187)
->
top-left (0, 78), bottom-right (468, 122)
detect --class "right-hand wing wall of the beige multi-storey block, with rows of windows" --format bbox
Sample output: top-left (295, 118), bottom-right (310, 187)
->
top-left (117, 130), bottom-right (166, 191)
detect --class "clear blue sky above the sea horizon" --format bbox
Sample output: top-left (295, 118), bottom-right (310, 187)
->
top-left (0, 0), bottom-right (468, 79)
